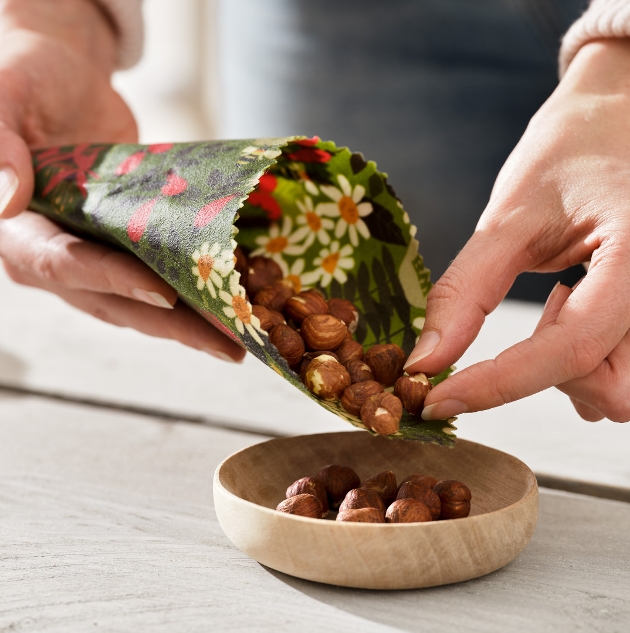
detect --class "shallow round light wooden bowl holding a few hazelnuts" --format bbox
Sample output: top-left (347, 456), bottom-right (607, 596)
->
top-left (214, 431), bottom-right (538, 589)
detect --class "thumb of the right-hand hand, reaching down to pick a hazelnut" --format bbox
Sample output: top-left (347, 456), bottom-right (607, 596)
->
top-left (405, 228), bottom-right (526, 376)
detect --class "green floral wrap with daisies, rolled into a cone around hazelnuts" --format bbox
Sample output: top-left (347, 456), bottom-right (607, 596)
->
top-left (31, 137), bottom-right (455, 446)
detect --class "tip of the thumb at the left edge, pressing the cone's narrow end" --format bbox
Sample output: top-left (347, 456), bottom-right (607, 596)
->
top-left (0, 123), bottom-right (34, 220)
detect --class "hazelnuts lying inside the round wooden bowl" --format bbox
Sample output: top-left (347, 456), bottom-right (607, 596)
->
top-left (276, 464), bottom-right (471, 523)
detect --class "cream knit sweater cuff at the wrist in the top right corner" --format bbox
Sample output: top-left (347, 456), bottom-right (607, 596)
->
top-left (560, 0), bottom-right (630, 77)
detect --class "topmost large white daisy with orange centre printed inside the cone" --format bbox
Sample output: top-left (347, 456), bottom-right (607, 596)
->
top-left (316, 174), bottom-right (373, 246)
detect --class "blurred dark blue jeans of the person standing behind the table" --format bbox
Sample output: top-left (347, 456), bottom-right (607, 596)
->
top-left (218, 0), bottom-right (588, 301)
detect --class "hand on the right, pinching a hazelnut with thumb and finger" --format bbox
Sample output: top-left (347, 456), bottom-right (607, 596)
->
top-left (407, 40), bottom-right (630, 422)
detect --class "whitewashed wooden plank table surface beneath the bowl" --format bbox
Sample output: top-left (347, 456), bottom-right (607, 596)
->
top-left (0, 276), bottom-right (630, 633)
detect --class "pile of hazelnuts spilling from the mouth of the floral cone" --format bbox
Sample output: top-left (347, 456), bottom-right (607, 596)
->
top-left (235, 248), bottom-right (432, 435)
